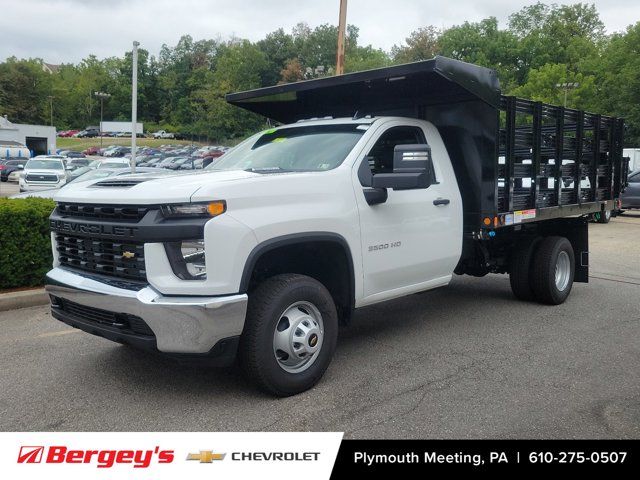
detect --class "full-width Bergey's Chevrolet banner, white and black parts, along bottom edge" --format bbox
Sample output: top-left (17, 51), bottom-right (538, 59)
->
top-left (0, 432), bottom-right (640, 480)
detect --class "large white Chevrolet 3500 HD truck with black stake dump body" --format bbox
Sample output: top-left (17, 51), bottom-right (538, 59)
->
top-left (47, 57), bottom-right (622, 396)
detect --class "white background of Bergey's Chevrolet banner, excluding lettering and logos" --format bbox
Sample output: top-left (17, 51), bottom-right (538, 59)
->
top-left (0, 432), bottom-right (342, 480)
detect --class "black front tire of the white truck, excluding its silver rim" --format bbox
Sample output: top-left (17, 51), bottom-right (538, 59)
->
top-left (239, 274), bottom-right (338, 397)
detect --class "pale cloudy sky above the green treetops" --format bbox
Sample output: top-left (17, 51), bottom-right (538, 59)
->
top-left (0, 0), bottom-right (640, 64)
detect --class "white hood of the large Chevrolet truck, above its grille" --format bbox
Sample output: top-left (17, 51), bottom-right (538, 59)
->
top-left (56, 170), bottom-right (262, 205)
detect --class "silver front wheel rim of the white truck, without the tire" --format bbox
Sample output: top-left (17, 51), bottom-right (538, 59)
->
top-left (273, 302), bottom-right (324, 373)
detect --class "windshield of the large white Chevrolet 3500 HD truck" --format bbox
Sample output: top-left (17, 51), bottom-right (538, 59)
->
top-left (207, 124), bottom-right (366, 172)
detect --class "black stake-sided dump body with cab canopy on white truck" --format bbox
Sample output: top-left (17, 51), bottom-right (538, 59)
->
top-left (227, 57), bottom-right (623, 239)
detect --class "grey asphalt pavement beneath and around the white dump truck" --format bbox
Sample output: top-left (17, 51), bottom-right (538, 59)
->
top-left (0, 216), bottom-right (640, 438)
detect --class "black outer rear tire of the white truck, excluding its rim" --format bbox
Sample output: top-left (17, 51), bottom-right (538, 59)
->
top-left (531, 237), bottom-right (575, 305)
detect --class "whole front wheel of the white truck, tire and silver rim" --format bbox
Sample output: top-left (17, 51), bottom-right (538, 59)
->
top-left (239, 274), bottom-right (338, 397)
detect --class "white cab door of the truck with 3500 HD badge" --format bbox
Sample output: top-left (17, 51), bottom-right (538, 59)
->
top-left (354, 119), bottom-right (462, 306)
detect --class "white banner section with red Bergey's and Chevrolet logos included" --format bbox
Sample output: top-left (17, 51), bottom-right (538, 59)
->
top-left (0, 432), bottom-right (342, 480)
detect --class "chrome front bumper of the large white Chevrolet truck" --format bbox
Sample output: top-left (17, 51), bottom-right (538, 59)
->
top-left (46, 267), bottom-right (247, 355)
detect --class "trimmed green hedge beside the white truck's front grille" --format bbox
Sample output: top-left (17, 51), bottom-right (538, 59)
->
top-left (0, 198), bottom-right (55, 289)
